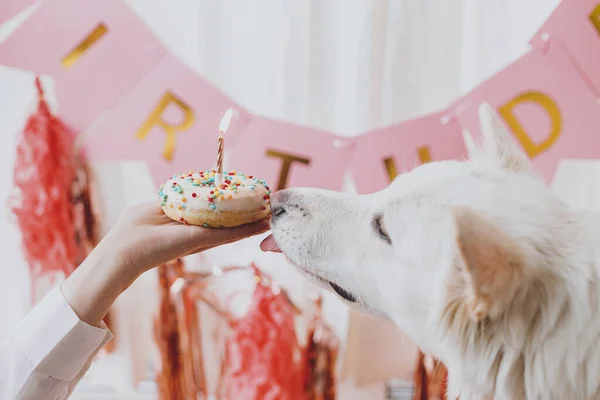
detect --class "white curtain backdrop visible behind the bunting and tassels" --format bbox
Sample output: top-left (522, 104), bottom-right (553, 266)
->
top-left (0, 0), bottom-right (572, 399)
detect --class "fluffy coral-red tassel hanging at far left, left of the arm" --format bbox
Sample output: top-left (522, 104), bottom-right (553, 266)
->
top-left (10, 78), bottom-right (77, 299)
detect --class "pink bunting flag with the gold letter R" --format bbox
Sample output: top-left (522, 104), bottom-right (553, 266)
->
top-left (86, 56), bottom-right (252, 185)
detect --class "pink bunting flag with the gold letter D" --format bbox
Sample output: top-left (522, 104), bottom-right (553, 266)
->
top-left (456, 42), bottom-right (600, 180)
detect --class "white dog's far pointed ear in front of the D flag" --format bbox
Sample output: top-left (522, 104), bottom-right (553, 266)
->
top-left (463, 103), bottom-right (533, 172)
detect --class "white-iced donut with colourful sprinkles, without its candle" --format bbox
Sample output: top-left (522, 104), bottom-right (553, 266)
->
top-left (158, 170), bottom-right (271, 228)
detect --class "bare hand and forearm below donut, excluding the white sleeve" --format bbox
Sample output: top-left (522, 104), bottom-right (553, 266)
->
top-left (61, 203), bottom-right (269, 326)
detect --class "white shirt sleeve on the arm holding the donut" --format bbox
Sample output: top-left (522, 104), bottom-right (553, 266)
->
top-left (0, 287), bottom-right (112, 400)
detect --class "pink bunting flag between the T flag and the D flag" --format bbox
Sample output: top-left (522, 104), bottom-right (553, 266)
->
top-left (350, 113), bottom-right (465, 194)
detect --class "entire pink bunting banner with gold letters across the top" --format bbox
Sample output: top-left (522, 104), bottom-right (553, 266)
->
top-left (0, 0), bottom-right (600, 193)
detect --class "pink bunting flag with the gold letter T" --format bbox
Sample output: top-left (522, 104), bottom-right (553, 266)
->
top-left (229, 117), bottom-right (353, 190)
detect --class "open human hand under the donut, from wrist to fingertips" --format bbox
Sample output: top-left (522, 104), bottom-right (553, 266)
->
top-left (101, 203), bottom-right (269, 273)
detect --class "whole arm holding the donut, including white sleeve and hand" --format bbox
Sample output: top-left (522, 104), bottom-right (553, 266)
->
top-left (0, 204), bottom-right (268, 400)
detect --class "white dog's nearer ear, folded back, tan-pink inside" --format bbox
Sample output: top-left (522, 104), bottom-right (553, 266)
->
top-left (453, 207), bottom-right (523, 321)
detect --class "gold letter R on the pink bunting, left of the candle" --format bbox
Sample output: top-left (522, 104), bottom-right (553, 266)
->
top-left (135, 92), bottom-right (194, 161)
